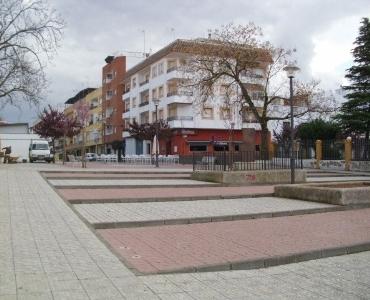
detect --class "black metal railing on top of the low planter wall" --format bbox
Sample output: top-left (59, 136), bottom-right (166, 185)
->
top-left (192, 151), bottom-right (303, 171)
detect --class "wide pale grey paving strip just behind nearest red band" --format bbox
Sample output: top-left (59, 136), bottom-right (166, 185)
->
top-left (74, 197), bottom-right (339, 227)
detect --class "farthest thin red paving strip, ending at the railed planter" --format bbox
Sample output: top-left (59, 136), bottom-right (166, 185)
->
top-left (44, 172), bottom-right (190, 179)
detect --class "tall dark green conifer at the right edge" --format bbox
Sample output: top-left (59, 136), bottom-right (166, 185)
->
top-left (336, 18), bottom-right (370, 139)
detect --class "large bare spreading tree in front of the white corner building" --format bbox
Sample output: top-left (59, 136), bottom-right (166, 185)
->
top-left (185, 23), bottom-right (333, 150)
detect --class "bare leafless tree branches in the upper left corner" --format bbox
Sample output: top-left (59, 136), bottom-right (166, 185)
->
top-left (0, 0), bottom-right (64, 108)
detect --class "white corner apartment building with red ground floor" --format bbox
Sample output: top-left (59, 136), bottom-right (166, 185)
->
top-left (122, 40), bottom-right (274, 155)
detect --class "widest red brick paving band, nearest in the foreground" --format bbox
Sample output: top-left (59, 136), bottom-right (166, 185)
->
top-left (98, 209), bottom-right (370, 273)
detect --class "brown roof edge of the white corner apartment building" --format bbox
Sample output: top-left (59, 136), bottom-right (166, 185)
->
top-left (125, 38), bottom-right (271, 78)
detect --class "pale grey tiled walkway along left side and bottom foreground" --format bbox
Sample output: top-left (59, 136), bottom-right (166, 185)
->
top-left (0, 164), bottom-right (370, 300)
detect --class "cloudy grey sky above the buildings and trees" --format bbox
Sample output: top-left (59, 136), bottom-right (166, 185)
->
top-left (0, 0), bottom-right (370, 124)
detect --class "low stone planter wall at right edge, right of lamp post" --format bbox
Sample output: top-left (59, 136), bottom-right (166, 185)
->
top-left (274, 182), bottom-right (370, 205)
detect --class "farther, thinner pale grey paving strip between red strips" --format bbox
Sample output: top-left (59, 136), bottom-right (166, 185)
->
top-left (49, 178), bottom-right (212, 187)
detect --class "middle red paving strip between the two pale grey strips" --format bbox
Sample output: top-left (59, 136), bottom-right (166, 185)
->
top-left (59, 185), bottom-right (274, 200)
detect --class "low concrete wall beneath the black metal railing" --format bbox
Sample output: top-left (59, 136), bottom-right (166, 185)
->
top-left (191, 169), bottom-right (306, 185)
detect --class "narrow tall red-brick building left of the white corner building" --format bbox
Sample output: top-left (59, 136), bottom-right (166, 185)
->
top-left (102, 56), bottom-right (126, 153)
